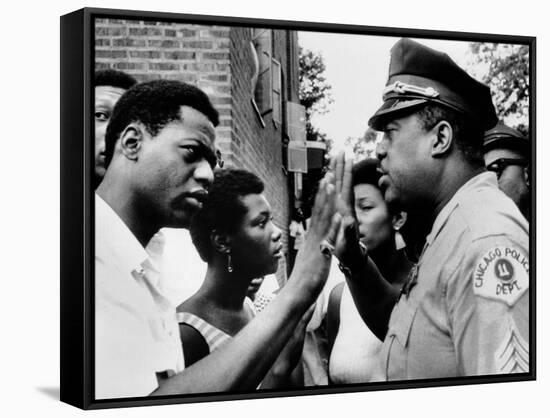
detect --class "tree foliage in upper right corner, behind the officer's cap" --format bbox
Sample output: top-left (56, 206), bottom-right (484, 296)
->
top-left (470, 42), bottom-right (530, 135)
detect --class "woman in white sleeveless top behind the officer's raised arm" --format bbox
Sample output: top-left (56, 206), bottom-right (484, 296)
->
top-left (327, 159), bottom-right (412, 383)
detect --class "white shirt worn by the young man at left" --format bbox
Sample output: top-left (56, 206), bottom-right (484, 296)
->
top-left (95, 195), bottom-right (184, 399)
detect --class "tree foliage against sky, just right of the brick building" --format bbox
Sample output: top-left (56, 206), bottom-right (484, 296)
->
top-left (299, 48), bottom-right (334, 142)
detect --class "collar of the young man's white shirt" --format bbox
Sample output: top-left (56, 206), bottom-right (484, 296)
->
top-left (95, 193), bottom-right (148, 272)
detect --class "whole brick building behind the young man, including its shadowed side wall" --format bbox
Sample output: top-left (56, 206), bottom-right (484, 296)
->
top-left (95, 19), bottom-right (305, 279)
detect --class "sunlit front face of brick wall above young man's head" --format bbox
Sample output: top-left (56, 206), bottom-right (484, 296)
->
top-left (95, 19), bottom-right (231, 148)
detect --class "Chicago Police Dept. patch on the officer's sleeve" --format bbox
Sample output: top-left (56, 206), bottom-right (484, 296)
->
top-left (473, 246), bottom-right (529, 306)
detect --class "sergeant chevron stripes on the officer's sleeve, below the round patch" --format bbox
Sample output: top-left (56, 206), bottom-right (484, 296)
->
top-left (495, 325), bottom-right (529, 374)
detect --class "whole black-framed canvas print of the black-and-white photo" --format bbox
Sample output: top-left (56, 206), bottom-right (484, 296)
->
top-left (61, 8), bottom-right (536, 409)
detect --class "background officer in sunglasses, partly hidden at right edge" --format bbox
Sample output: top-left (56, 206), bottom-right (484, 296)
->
top-left (483, 122), bottom-right (531, 220)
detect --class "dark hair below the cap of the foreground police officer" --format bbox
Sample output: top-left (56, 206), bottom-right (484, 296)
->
top-left (416, 103), bottom-right (484, 166)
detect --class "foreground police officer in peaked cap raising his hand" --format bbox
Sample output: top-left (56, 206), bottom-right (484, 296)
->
top-left (336, 39), bottom-right (529, 380)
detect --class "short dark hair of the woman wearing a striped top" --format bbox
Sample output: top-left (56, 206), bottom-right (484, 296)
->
top-left (190, 169), bottom-right (264, 263)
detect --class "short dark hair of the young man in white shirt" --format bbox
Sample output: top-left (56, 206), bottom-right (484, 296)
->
top-left (105, 80), bottom-right (219, 165)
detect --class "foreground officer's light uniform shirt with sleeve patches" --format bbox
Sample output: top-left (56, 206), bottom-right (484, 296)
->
top-left (381, 173), bottom-right (529, 380)
